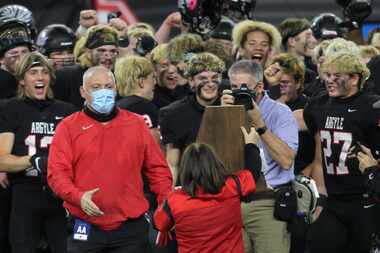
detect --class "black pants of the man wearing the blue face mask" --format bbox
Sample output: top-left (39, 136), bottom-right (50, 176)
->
top-left (68, 216), bottom-right (149, 253)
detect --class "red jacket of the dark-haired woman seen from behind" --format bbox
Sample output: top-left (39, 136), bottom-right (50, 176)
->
top-left (154, 170), bottom-right (256, 253)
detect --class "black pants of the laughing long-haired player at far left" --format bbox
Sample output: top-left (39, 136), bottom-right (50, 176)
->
top-left (10, 184), bottom-right (67, 253)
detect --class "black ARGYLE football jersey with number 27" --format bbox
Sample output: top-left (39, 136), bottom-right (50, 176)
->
top-left (304, 92), bottom-right (380, 195)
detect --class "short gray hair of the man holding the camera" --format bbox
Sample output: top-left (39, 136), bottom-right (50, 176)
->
top-left (228, 60), bottom-right (263, 83)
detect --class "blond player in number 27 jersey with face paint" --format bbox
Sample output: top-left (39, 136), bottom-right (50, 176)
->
top-left (304, 51), bottom-right (380, 253)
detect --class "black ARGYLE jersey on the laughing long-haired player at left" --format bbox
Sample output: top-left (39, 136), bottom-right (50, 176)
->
top-left (0, 98), bottom-right (76, 183)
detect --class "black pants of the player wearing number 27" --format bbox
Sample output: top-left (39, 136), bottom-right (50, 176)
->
top-left (308, 198), bottom-right (375, 253)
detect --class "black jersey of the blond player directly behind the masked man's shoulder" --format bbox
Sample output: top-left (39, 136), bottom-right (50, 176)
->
top-left (117, 95), bottom-right (158, 128)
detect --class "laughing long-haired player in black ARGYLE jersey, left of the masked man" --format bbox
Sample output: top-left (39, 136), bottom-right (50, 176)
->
top-left (0, 52), bottom-right (75, 253)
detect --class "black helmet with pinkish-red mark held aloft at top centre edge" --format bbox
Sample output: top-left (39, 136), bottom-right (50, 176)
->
top-left (178, 0), bottom-right (222, 35)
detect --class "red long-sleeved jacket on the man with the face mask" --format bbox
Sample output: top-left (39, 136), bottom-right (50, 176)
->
top-left (48, 110), bottom-right (172, 230)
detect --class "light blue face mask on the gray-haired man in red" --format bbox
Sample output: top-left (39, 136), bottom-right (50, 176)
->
top-left (90, 89), bottom-right (116, 114)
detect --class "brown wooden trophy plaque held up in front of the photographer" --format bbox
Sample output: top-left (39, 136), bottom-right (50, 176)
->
top-left (197, 105), bottom-right (249, 172)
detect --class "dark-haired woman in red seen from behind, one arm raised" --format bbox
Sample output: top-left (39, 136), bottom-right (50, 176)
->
top-left (154, 127), bottom-right (261, 253)
